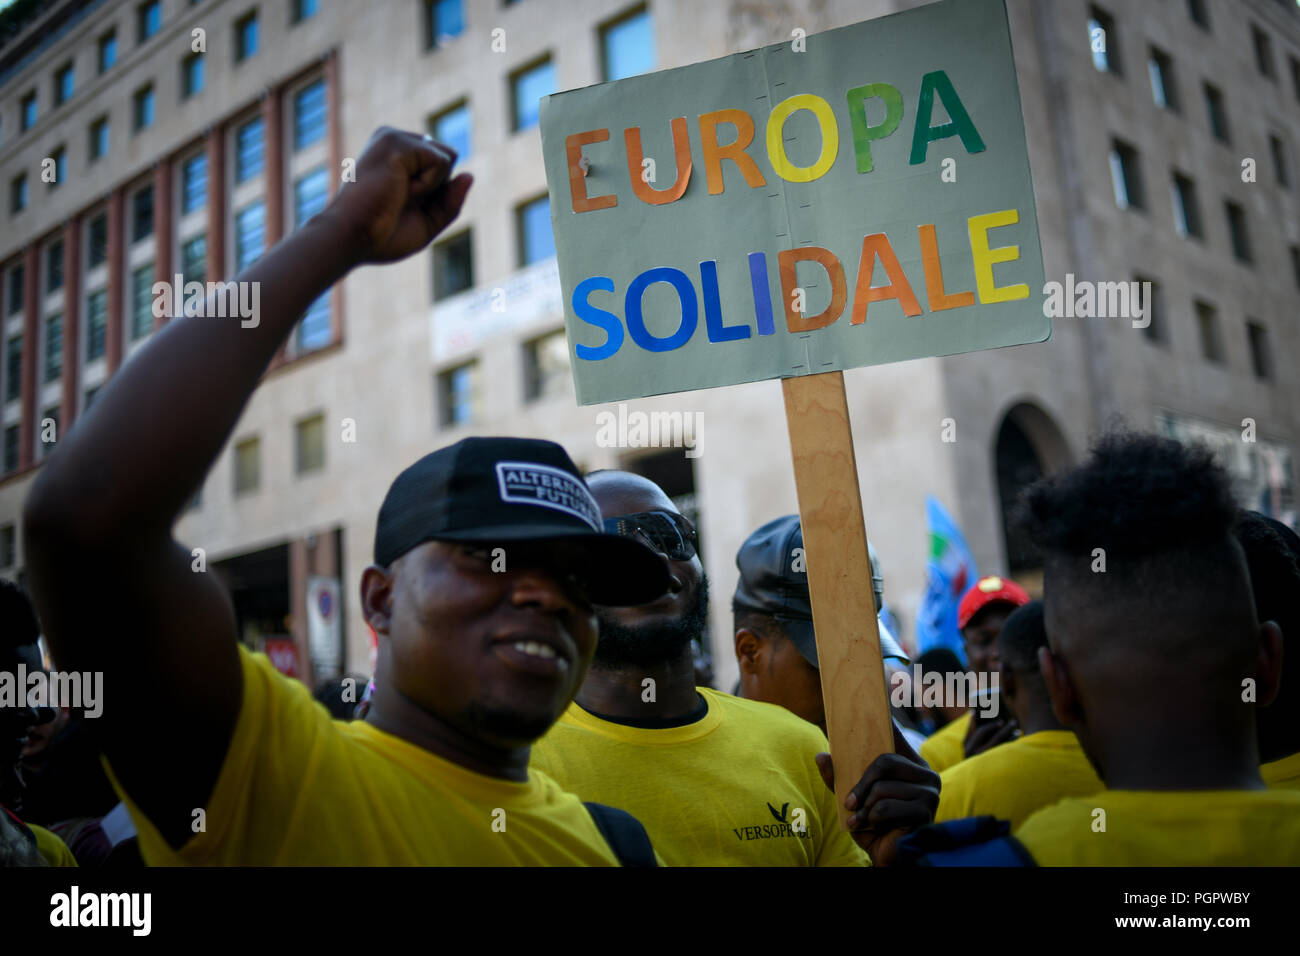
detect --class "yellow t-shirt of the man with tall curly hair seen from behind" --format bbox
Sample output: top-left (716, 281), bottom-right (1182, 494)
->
top-left (1014, 790), bottom-right (1300, 866)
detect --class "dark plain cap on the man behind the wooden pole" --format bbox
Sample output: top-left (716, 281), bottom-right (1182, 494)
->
top-left (732, 515), bottom-right (907, 667)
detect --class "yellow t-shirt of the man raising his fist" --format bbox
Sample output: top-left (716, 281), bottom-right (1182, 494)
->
top-left (105, 648), bottom-right (634, 866)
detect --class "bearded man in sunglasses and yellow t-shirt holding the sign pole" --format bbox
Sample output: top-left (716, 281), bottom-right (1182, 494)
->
top-left (533, 471), bottom-right (939, 866)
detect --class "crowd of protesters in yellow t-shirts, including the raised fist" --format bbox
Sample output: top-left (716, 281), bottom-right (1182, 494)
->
top-left (0, 130), bottom-right (1300, 866)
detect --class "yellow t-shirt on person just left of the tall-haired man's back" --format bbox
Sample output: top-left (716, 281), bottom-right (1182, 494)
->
top-left (935, 730), bottom-right (1106, 829)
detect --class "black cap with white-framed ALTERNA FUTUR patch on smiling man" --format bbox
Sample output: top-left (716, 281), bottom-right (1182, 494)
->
top-left (374, 438), bottom-right (670, 606)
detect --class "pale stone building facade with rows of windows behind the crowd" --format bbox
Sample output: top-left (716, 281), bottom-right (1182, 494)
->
top-left (0, 0), bottom-right (1300, 689)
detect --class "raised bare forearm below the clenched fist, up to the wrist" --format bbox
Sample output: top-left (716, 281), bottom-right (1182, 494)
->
top-left (29, 213), bottom-right (354, 546)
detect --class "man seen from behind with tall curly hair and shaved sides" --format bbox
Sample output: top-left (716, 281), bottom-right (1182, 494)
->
top-left (1014, 433), bottom-right (1300, 866)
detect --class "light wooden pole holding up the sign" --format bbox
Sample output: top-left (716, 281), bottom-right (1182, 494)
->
top-left (781, 372), bottom-right (893, 829)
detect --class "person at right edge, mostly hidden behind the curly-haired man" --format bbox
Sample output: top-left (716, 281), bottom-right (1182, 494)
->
top-left (1235, 511), bottom-right (1300, 790)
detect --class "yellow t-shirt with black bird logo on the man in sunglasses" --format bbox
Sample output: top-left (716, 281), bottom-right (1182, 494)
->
top-left (532, 687), bottom-right (868, 866)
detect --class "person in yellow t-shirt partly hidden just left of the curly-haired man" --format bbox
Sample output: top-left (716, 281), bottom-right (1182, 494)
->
top-left (935, 601), bottom-right (1104, 827)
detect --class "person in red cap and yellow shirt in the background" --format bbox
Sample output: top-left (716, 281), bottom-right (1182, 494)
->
top-left (920, 575), bottom-right (1030, 774)
